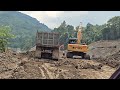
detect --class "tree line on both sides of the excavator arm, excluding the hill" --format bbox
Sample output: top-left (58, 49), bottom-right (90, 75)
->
top-left (53, 16), bottom-right (120, 47)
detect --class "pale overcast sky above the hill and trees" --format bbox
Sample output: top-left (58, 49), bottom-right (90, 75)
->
top-left (20, 11), bottom-right (120, 29)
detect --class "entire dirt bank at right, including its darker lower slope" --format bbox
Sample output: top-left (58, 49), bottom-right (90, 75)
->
top-left (88, 40), bottom-right (120, 68)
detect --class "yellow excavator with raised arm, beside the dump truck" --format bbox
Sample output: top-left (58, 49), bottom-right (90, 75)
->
top-left (66, 22), bottom-right (90, 60)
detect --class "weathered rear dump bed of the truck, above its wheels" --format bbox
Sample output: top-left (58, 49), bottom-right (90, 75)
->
top-left (36, 32), bottom-right (60, 47)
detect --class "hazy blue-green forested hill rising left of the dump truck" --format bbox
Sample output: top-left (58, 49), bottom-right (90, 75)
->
top-left (0, 11), bottom-right (51, 49)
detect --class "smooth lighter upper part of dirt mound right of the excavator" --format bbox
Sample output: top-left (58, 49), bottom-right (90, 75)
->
top-left (88, 40), bottom-right (120, 58)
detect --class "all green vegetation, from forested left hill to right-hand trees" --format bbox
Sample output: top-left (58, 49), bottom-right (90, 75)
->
top-left (0, 11), bottom-right (120, 51)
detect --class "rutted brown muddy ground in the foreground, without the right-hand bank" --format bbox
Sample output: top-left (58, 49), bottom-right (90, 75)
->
top-left (0, 52), bottom-right (116, 79)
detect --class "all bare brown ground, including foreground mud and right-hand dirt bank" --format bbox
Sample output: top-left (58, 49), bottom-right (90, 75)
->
top-left (0, 40), bottom-right (120, 79)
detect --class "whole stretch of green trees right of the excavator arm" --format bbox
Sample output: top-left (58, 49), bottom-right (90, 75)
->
top-left (83, 16), bottom-right (120, 44)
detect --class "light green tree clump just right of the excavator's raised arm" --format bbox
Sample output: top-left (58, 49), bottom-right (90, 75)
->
top-left (82, 23), bottom-right (104, 44)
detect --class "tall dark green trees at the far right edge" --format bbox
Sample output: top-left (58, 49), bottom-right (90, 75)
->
top-left (102, 16), bottom-right (120, 40)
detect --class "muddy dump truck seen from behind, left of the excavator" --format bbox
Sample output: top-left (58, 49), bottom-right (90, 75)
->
top-left (35, 32), bottom-right (60, 60)
